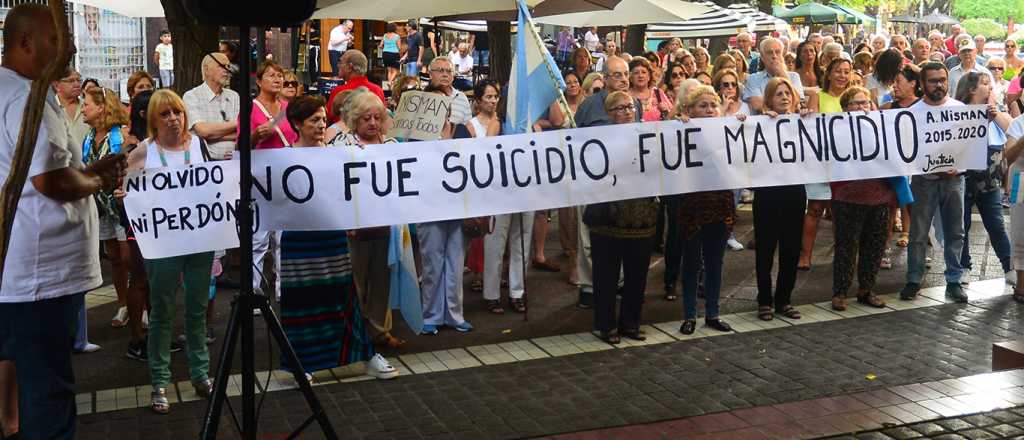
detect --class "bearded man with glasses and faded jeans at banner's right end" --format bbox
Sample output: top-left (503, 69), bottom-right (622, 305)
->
top-left (899, 61), bottom-right (973, 303)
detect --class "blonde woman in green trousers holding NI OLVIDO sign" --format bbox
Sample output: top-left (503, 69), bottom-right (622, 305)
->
top-left (118, 89), bottom-right (213, 414)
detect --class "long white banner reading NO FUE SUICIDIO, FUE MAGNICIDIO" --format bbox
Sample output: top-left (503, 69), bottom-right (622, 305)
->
top-left (123, 105), bottom-right (988, 258)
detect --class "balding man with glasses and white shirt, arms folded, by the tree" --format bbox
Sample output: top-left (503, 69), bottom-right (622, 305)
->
top-left (182, 53), bottom-right (240, 161)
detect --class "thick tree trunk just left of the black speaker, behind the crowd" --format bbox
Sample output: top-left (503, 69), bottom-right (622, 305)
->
top-left (160, 0), bottom-right (219, 95)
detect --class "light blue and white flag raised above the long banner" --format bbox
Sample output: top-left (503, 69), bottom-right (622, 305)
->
top-left (504, 0), bottom-right (565, 134)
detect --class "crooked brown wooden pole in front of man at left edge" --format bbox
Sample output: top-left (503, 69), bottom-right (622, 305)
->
top-left (0, 0), bottom-right (71, 284)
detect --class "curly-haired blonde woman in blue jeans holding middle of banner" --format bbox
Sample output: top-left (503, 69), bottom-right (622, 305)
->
top-left (672, 86), bottom-right (733, 335)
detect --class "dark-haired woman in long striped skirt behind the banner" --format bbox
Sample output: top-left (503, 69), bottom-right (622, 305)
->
top-left (281, 93), bottom-right (398, 379)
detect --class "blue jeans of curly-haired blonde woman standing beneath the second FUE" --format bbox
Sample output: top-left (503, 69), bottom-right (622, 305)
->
top-left (680, 221), bottom-right (729, 319)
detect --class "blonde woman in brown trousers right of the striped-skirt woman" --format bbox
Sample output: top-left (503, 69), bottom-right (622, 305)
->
top-left (331, 87), bottom-right (406, 349)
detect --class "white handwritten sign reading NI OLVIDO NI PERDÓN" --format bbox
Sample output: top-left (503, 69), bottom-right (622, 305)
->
top-left (124, 161), bottom-right (240, 259)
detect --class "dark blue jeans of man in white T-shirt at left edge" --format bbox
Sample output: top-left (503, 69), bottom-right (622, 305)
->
top-left (0, 294), bottom-right (85, 439)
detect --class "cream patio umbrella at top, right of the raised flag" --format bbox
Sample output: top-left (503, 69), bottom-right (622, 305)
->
top-left (535, 0), bottom-right (711, 28)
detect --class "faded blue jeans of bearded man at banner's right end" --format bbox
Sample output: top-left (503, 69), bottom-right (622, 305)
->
top-left (906, 176), bottom-right (964, 284)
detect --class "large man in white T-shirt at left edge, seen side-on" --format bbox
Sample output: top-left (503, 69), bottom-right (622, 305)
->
top-left (0, 4), bottom-right (125, 439)
